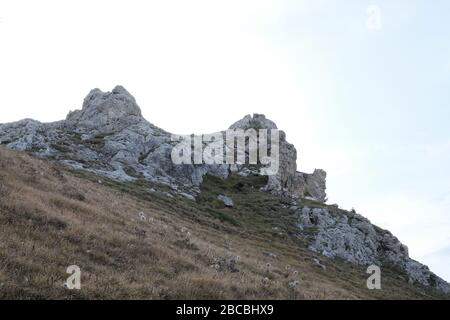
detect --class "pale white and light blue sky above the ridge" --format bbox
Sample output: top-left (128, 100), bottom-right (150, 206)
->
top-left (0, 0), bottom-right (450, 281)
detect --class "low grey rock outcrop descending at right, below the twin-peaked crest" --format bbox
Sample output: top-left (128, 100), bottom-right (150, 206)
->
top-left (296, 207), bottom-right (450, 292)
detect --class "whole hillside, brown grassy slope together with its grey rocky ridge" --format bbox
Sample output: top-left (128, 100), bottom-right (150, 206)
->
top-left (0, 86), bottom-right (450, 298)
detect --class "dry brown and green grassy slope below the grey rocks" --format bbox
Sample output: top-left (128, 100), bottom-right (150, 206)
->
top-left (0, 148), bottom-right (448, 299)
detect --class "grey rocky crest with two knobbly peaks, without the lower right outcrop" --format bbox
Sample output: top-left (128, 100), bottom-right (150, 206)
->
top-left (0, 86), bottom-right (326, 202)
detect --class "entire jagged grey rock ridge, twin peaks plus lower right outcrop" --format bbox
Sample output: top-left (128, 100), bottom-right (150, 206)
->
top-left (0, 86), bottom-right (450, 293)
